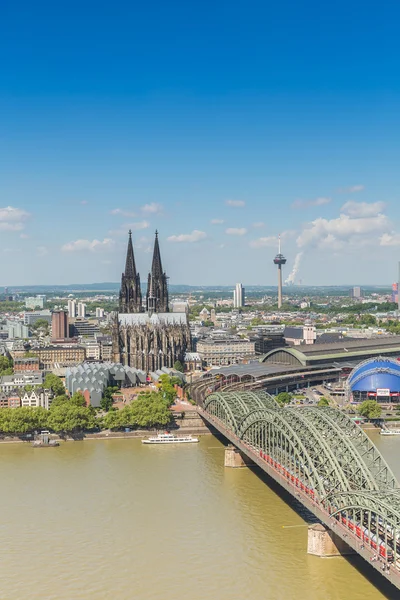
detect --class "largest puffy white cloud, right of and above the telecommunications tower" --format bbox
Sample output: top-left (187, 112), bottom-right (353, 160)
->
top-left (297, 214), bottom-right (390, 249)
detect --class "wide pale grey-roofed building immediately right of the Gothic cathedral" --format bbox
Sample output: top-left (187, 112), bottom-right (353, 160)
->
top-left (197, 336), bottom-right (255, 367)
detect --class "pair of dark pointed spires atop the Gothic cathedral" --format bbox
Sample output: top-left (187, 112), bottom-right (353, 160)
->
top-left (119, 231), bottom-right (169, 313)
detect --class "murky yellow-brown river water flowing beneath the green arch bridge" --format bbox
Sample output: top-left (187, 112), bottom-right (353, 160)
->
top-left (0, 434), bottom-right (400, 600)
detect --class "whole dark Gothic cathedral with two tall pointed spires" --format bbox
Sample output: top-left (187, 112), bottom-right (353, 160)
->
top-left (112, 232), bottom-right (191, 372)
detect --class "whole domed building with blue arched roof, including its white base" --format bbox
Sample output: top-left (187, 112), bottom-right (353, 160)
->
top-left (347, 356), bottom-right (400, 404)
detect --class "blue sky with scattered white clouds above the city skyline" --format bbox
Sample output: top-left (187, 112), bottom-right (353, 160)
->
top-left (0, 0), bottom-right (400, 286)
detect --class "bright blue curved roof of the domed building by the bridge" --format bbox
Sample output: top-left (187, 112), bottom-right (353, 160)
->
top-left (348, 358), bottom-right (400, 392)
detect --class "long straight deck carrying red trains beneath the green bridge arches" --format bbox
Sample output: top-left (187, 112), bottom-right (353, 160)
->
top-left (198, 407), bottom-right (400, 589)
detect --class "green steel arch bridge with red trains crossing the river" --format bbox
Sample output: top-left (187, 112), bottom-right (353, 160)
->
top-left (199, 391), bottom-right (400, 589)
